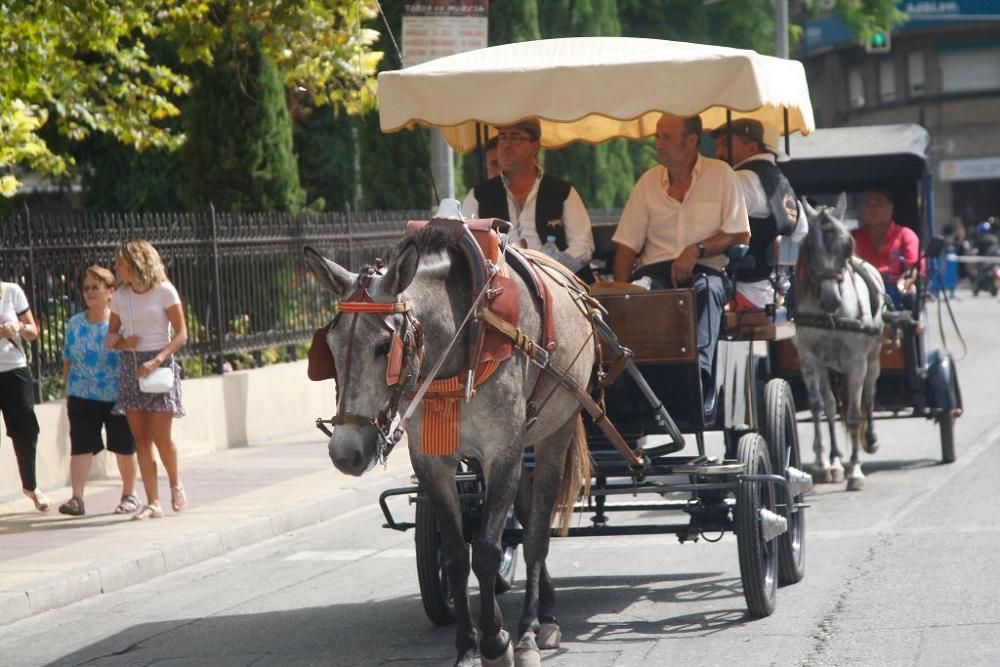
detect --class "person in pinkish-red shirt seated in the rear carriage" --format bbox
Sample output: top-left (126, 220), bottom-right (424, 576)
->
top-left (852, 185), bottom-right (920, 308)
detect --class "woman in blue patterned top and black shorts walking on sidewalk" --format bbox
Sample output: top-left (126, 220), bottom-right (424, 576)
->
top-left (59, 265), bottom-right (139, 516)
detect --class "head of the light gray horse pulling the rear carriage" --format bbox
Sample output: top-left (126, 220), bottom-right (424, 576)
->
top-left (798, 193), bottom-right (854, 314)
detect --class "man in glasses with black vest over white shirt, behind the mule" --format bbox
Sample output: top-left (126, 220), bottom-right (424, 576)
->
top-left (462, 119), bottom-right (594, 282)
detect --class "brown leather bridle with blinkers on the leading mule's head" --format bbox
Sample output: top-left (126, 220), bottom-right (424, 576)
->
top-left (316, 258), bottom-right (424, 463)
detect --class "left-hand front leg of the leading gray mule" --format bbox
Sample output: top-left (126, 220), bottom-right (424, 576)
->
top-left (410, 452), bottom-right (478, 667)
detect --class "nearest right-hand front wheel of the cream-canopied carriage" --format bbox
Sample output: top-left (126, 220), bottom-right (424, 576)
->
top-left (734, 433), bottom-right (778, 618)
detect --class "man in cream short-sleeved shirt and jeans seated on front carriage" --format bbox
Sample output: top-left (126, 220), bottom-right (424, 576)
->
top-left (612, 113), bottom-right (750, 412)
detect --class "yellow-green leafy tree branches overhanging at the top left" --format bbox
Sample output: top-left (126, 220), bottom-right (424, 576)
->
top-left (0, 0), bottom-right (381, 196)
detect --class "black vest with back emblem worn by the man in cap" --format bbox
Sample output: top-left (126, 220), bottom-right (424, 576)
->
top-left (736, 160), bottom-right (799, 281)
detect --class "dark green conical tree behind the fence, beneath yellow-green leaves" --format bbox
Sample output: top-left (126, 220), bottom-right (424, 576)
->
top-left (183, 35), bottom-right (305, 212)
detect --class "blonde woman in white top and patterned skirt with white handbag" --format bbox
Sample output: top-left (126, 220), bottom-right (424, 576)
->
top-left (104, 240), bottom-right (187, 520)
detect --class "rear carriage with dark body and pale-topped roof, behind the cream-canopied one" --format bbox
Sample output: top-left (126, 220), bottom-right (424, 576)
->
top-left (759, 125), bottom-right (962, 463)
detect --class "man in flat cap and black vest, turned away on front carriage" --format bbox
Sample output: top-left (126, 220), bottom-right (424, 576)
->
top-left (711, 118), bottom-right (809, 310)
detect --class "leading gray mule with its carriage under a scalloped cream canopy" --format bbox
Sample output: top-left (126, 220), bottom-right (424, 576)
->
top-left (307, 38), bottom-right (813, 665)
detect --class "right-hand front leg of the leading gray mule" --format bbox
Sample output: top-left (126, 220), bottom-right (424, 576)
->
top-left (472, 445), bottom-right (523, 666)
